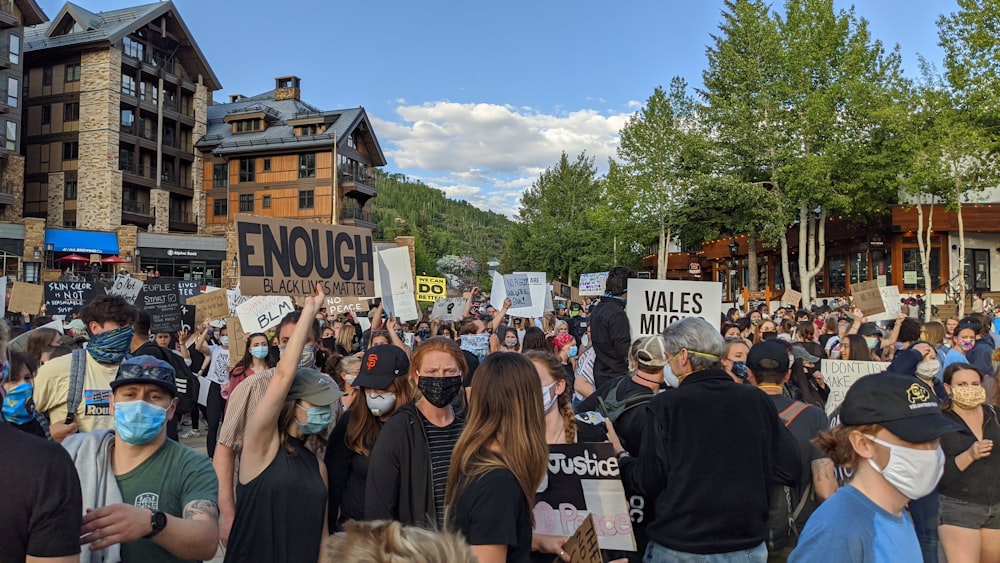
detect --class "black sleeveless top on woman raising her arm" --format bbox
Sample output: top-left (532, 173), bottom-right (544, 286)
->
top-left (225, 437), bottom-right (326, 563)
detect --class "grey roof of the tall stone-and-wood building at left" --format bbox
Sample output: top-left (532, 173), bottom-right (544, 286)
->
top-left (24, 0), bottom-right (222, 90)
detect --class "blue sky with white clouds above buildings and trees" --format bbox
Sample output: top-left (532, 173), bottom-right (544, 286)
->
top-left (38, 0), bottom-right (956, 216)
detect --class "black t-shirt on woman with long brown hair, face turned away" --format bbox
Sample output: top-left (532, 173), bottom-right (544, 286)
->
top-left (452, 468), bottom-right (531, 562)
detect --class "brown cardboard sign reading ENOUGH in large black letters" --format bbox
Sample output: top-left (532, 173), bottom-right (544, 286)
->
top-left (236, 215), bottom-right (376, 297)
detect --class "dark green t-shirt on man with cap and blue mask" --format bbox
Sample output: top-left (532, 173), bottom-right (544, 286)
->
top-left (115, 439), bottom-right (219, 563)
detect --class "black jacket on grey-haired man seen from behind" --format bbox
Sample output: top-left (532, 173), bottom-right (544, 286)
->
top-left (622, 369), bottom-right (801, 554)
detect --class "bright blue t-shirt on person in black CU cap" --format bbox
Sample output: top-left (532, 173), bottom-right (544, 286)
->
top-left (788, 485), bottom-right (923, 563)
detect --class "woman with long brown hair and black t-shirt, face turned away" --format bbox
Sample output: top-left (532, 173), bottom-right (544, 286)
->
top-left (445, 354), bottom-right (548, 563)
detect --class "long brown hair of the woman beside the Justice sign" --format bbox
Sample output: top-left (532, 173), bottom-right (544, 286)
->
top-left (444, 353), bottom-right (549, 523)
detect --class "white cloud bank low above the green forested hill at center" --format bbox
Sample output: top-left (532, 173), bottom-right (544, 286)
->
top-left (372, 101), bottom-right (629, 217)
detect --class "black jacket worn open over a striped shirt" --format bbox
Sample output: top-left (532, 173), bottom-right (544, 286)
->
top-left (365, 402), bottom-right (438, 527)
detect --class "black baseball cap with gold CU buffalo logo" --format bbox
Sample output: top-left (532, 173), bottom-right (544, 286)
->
top-left (840, 372), bottom-right (962, 443)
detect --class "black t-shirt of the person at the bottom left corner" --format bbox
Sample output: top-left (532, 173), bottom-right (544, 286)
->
top-left (0, 422), bottom-right (83, 562)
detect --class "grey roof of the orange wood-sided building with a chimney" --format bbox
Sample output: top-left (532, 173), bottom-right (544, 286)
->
top-left (195, 91), bottom-right (386, 166)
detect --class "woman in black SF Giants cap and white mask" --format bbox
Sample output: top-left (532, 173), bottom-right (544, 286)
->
top-left (324, 344), bottom-right (414, 533)
